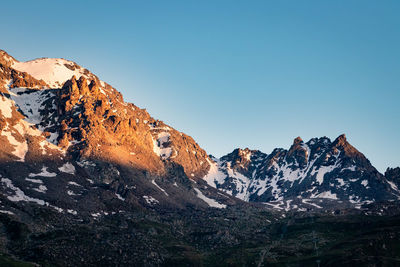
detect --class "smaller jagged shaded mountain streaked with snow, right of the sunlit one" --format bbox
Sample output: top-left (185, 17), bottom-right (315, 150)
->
top-left (205, 135), bottom-right (400, 209)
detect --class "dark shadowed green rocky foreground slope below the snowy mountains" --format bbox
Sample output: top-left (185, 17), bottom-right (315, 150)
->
top-left (0, 208), bottom-right (400, 266)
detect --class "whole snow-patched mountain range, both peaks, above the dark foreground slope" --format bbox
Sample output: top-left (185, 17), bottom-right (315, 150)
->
top-left (0, 48), bottom-right (400, 217)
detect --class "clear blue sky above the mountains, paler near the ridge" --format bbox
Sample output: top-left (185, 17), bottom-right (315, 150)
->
top-left (0, 0), bottom-right (400, 171)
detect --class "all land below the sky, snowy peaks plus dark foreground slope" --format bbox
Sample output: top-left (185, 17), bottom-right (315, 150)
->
top-left (0, 50), bottom-right (400, 266)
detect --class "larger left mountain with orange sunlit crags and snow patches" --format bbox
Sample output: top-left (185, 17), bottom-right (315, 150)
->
top-left (0, 48), bottom-right (234, 216)
